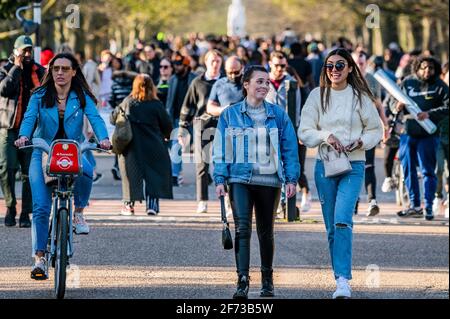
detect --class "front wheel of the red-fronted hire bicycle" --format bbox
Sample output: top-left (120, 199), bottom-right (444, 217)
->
top-left (55, 207), bottom-right (69, 299)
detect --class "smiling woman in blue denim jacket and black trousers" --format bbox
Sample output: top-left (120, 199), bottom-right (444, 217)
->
top-left (213, 66), bottom-right (300, 299)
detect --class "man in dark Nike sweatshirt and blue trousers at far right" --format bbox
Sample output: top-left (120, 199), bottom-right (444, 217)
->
top-left (395, 56), bottom-right (448, 220)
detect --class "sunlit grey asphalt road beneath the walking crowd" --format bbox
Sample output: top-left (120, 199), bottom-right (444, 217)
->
top-left (0, 151), bottom-right (449, 300)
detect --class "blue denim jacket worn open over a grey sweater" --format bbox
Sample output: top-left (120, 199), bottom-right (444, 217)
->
top-left (213, 99), bottom-right (300, 185)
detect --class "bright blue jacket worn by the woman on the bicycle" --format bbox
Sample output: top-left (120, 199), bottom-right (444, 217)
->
top-left (19, 90), bottom-right (108, 144)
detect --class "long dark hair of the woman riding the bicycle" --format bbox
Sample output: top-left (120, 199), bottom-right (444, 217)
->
top-left (33, 53), bottom-right (97, 109)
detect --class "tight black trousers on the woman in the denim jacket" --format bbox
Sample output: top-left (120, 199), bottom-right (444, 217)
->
top-left (230, 183), bottom-right (281, 276)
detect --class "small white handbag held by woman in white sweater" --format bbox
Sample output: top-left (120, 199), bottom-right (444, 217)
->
top-left (319, 142), bottom-right (352, 177)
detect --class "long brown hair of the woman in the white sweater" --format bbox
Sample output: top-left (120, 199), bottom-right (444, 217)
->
top-left (320, 49), bottom-right (375, 113)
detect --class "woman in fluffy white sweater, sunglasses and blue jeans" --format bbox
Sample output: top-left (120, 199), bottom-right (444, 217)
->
top-left (298, 49), bottom-right (383, 298)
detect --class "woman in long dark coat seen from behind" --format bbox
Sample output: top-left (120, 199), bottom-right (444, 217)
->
top-left (111, 73), bottom-right (173, 216)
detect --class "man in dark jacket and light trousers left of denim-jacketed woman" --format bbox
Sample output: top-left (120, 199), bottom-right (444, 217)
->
top-left (178, 50), bottom-right (223, 213)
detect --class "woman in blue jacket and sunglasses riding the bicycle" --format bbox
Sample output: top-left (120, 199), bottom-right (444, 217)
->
top-left (15, 53), bottom-right (111, 279)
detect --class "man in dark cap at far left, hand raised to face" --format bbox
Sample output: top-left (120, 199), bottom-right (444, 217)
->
top-left (0, 35), bottom-right (45, 227)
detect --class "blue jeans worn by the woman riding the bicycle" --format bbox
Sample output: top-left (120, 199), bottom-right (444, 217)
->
top-left (29, 150), bottom-right (93, 256)
